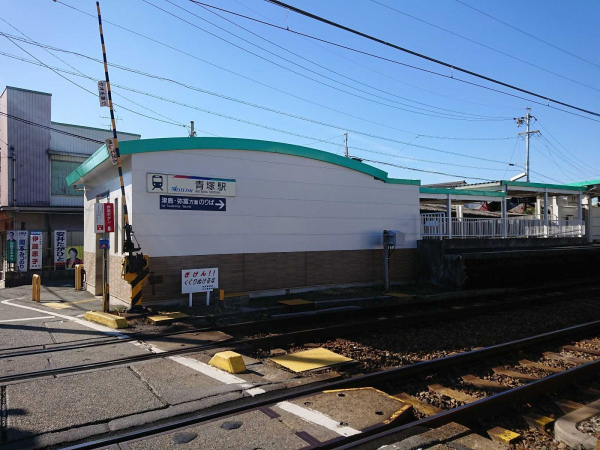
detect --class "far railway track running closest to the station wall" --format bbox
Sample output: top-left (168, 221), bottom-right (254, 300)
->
top-left (0, 281), bottom-right (600, 385)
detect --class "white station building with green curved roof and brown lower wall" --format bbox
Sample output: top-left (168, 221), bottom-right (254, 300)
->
top-left (67, 137), bottom-right (420, 305)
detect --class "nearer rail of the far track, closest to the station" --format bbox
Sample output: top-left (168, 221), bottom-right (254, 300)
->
top-left (0, 287), bottom-right (600, 385)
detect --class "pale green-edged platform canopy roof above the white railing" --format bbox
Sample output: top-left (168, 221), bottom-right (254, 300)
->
top-left (456, 180), bottom-right (586, 198)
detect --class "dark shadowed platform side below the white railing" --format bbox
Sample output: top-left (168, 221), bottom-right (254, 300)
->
top-left (418, 238), bottom-right (600, 289)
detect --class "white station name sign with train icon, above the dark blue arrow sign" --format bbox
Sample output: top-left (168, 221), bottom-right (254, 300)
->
top-left (146, 173), bottom-right (235, 197)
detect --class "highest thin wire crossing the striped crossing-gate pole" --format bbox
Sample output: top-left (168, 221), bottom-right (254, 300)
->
top-left (50, 0), bottom-right (524, 141)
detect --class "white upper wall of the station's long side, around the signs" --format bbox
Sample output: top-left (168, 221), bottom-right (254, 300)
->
top-left (131, 150), bottom-right (419, 257)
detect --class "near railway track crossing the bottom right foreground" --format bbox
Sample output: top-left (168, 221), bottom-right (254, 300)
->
top-left (59, 321), bottom-right (600, 450)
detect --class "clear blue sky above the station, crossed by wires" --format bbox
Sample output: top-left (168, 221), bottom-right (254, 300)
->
top-left (0, 0), bottom-right (600, 183)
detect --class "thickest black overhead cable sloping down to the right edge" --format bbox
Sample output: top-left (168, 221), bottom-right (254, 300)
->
top-left (264, 0), bottom-right (600, 117)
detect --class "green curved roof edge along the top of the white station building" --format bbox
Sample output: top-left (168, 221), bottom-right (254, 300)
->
top-left (67, 137), bottom-right (421, 186)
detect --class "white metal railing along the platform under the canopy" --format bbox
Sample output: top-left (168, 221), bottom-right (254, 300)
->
top-left (421, 213), bottom-right (585, 239)
